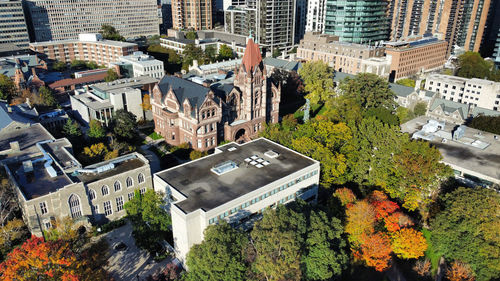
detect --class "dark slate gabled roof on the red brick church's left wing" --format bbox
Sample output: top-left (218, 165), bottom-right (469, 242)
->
top-left (158, 75), bottom-right (210, 112)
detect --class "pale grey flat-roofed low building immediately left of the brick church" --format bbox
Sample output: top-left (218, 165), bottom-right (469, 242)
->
top-left (70, 76), bottom-right (158, 125)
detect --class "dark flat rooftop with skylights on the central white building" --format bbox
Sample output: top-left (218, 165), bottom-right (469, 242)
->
top-left (155, 138), bottom-right (317, 213)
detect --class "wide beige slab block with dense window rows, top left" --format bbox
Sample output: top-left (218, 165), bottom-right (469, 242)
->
top-left (25, 0), bottom-right (160, 42)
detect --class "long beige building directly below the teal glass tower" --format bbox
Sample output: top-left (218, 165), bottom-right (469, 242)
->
top-left (297, 32), bottom-right (390, 76)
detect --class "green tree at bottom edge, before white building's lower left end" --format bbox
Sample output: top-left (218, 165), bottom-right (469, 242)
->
top-left (186, 221), bottom-right (249, 281)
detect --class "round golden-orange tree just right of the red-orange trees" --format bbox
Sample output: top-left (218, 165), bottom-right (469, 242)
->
top-left (391, 228), bottom-right (427, 259)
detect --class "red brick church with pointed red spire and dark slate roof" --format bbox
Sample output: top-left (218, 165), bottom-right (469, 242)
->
top-left (151, 39), bottom-right (281, 150)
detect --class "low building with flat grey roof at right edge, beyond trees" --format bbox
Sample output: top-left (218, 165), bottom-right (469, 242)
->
top-left (401, 116), bottom-right (500, 188)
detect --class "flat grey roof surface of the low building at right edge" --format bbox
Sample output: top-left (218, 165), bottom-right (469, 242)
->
top-left (401, 116), bottom-right (500, 181)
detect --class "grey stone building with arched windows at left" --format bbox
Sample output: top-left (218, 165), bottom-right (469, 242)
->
top-left (0, 124), bottom-right (152, 235)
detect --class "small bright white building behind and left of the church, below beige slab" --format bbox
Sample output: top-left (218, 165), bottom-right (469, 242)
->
top-left (115, 51), bottom-right (165, 79)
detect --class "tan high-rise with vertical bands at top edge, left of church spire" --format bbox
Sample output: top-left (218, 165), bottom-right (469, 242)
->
top-left (172, 0), bottom-right (213, 30)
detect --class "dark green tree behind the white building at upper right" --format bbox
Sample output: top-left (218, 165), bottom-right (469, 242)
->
top-left (457, 51), bottom-right (492, 79)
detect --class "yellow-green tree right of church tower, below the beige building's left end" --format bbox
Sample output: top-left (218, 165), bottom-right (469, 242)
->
top-left (299, 61), bottom-right (334, 104)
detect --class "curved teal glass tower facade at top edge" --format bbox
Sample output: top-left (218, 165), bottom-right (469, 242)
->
top-left (325, 0), bottom-right (390, 43)
